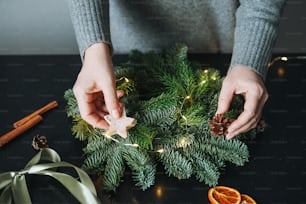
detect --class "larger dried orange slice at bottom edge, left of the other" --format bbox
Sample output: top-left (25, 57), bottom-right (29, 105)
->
top-left (208, 186), bottom-right (241, 204)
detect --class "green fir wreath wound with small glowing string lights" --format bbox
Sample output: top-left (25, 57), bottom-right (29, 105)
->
top-left (64, 45), bottom-right (256, 191)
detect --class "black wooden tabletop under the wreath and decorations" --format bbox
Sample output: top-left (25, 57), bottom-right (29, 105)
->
top-left (0, 54), bottom-right (306, 204)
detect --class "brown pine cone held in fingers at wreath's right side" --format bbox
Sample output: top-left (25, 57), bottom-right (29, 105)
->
top-left (208, 114), bottom-right (235, 136)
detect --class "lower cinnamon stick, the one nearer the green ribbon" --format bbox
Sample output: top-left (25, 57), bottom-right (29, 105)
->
top-left (0, 115), bottom-right (43, 147)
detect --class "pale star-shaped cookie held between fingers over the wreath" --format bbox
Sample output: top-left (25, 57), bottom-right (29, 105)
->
top-left (104, 107), bottom-right (137, 138)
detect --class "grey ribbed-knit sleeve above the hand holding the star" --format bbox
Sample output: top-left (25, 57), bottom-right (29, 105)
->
top-left (67, 0), bottom-right (111, 59)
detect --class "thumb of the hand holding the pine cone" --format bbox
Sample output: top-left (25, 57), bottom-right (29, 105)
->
top-left (216, 85), bottom-right (234, 114)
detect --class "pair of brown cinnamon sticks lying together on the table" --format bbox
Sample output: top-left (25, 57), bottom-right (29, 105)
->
top-left (0, 101), bottom-right (58, 147)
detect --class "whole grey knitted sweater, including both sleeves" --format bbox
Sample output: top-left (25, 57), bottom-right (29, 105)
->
top-left (67, 0), bottom-right (286, 79)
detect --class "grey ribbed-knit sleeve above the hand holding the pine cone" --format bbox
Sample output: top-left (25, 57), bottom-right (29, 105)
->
top-left (230, 0), bottom-right (285, 79)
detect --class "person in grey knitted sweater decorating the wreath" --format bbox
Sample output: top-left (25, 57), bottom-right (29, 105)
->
top-left (68, 0), bottom-right (285, 139)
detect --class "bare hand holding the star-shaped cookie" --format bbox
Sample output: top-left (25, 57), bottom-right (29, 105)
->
top-left (73, 43), bottom-right (124, 130)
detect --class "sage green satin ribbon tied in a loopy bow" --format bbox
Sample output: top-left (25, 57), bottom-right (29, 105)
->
top-left (0, 148), bottom-right (100, 204)
